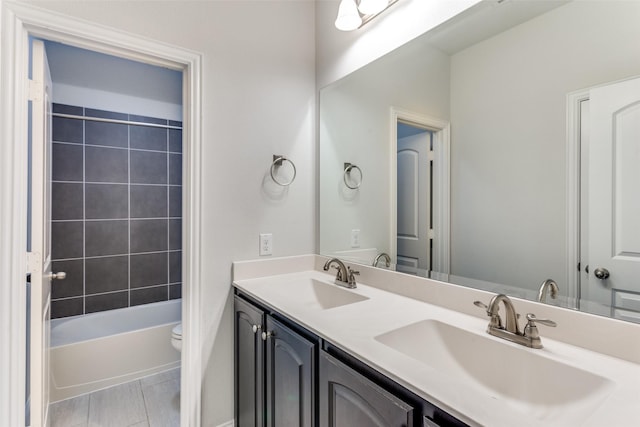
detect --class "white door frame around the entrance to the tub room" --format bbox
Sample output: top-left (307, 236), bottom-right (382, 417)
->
top-left (0, 1), bottom-right (202, 426)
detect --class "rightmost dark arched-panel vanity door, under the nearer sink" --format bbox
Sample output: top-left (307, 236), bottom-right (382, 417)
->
top-left (319, 351), bottom-right (414, 427)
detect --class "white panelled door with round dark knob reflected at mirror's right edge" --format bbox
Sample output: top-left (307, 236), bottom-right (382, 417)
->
top-left (582, 79), bottom-right (640, 314)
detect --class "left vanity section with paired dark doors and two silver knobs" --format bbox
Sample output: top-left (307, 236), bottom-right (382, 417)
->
top-left (234, 296), bottom-right (317, 427)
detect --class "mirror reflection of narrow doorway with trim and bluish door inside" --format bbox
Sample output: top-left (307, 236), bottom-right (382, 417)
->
top-left (390, 107), bottom-right (450, 281)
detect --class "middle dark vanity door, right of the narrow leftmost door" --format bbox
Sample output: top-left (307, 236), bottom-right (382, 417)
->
top-left (263, 316), bottom-right (315, 427)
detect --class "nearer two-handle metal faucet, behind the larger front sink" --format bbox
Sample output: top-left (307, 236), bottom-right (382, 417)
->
top-left (474, 294), bottom-right (556, 348)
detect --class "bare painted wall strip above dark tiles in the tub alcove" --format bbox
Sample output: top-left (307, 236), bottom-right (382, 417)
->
top-left (46, 42), bottom-right (182, 121)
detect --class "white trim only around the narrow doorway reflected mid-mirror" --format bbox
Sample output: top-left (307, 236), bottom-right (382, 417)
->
top-left (389, 106), bottom-right (450, 280)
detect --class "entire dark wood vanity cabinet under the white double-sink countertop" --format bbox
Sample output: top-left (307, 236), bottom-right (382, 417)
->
top-left (234, 291), bottom-right (466, 427)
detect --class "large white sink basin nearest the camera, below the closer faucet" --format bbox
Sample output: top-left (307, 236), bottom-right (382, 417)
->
top-left (375, 320), bottom-right (613, 425)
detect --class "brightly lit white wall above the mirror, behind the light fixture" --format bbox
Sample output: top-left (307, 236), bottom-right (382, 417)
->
top-left (316, 0), bottom-right (480, 88)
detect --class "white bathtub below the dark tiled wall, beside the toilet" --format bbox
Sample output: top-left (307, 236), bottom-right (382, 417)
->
top-left (50, 299), bottom-right (182, 402)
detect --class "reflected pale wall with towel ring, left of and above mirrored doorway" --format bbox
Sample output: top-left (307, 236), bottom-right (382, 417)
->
top-left (319, 41), bottom-right (450, 264)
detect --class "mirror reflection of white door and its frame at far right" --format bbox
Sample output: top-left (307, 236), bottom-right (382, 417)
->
top-left (568, 78), bottom-right (640, 322)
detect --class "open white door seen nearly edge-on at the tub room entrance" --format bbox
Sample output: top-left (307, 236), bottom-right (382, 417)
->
top-left (27, 40), bottom-right (57, 427)
